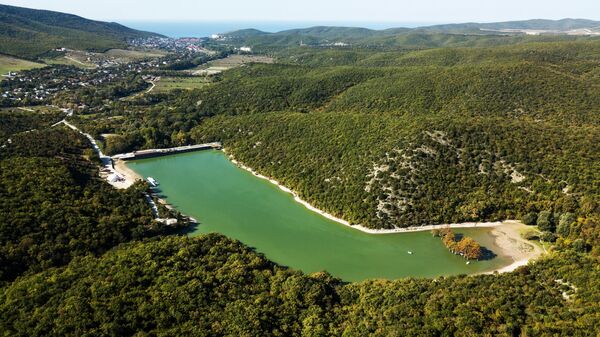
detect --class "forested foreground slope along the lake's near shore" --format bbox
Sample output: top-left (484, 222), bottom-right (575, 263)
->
top-left (0, 234), bottom-right (600, 336)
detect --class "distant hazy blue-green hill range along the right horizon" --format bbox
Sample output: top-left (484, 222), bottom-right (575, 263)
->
top-left (225, 19), bottom-right (600, 50)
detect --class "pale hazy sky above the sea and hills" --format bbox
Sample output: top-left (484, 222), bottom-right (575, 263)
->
top-left (0, 0), bottom-right (600, 23)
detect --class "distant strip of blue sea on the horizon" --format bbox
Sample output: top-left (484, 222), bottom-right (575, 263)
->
top-left (119, 21), bottom-right (439, 38)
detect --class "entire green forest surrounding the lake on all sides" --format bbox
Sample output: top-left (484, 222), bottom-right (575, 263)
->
top-left (0, 28), bottom-right (600, 336)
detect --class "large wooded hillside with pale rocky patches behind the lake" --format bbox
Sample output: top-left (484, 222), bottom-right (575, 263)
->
top-left (63, 41), bottom-right (600, 232)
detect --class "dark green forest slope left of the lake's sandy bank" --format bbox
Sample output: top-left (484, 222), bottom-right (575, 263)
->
top-left (0, 122), bottom-right (186, 284)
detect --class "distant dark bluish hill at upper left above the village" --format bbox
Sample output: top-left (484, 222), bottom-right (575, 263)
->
top-left (0, 5), bottom-right (161, 58)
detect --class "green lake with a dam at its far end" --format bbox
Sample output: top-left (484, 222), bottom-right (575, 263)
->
top-left (127, 150), bottom-right (512, 281)
